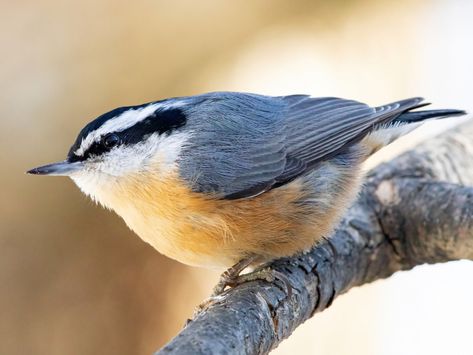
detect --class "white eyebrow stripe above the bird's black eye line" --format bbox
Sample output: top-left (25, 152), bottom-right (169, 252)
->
top-left (74, 102), bottom-right (183, 156)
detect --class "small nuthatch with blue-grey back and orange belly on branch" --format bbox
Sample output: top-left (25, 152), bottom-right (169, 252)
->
top-left (27, 92), bottom-right (465, 294)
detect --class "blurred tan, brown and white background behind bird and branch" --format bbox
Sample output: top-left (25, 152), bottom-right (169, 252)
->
top-left (0, 0), bottom-right (473, 355)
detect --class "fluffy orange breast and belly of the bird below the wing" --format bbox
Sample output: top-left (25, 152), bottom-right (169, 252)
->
top-left (97, 165), bottom-right (362, 268)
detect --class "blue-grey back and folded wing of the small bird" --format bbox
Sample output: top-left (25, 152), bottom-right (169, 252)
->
top-left (180, 93), bottom-right (422, 199)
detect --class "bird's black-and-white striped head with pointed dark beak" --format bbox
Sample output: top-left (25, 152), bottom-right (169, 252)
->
top-left (28, 99), bottom-right (189, 197)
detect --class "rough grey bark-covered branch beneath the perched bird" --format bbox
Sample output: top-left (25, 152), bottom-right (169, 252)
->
top-left (156, 123), bottom-right (473, 354)
